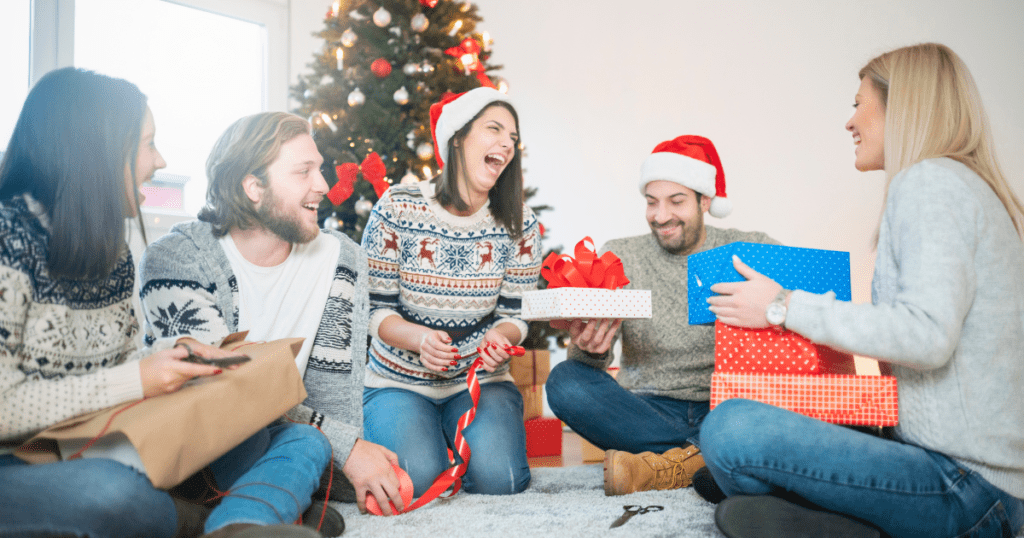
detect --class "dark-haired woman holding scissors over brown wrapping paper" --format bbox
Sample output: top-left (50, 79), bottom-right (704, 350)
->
top-left (0, 68), bottom-right (330, 537)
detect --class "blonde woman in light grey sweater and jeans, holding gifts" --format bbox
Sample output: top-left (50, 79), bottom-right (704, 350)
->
top-left (700, 44), bottom-right (1024, 538)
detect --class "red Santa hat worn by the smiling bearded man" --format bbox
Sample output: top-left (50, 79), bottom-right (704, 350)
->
top-left (640, 134), bottom-right (732, 218)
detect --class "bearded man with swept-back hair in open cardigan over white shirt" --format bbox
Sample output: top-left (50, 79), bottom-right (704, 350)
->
top-left (139, 113), bottom-right (403, 522)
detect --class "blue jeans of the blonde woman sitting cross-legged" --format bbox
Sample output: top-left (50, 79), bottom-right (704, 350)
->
top-left (700, 400), bottom-right (1024, 538)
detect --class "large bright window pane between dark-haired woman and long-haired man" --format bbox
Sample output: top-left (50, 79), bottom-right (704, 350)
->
top-left (74, 0), bottom-right (267, 215)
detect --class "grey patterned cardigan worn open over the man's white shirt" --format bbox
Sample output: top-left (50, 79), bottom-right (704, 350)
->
top-left (139, 220), bottom-right (370, 465)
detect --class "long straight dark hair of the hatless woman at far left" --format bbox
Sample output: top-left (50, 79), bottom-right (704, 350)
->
top-left (0, 68), bottom-right (146, 280)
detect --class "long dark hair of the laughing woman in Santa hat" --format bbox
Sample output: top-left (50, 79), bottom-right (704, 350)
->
top-left (434, 100), bottom-right (523, 240)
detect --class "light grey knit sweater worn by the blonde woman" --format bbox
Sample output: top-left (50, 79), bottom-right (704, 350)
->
top-left (785, 159), bottom-right (1024, 498)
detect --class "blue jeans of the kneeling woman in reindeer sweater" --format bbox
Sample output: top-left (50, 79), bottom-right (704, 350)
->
top-left (362, 381), bottom-right (530, 497)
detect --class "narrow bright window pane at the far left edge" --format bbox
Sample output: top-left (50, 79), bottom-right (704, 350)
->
top-left (0, 0), bottom-right (31, 154)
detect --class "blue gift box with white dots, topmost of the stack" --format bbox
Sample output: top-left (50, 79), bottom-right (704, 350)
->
top-left (686, 242), bottom-right (850, 325)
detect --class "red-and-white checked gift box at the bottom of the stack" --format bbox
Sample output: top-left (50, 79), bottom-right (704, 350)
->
top-left (711, 372), bottom-right (899, 426)
